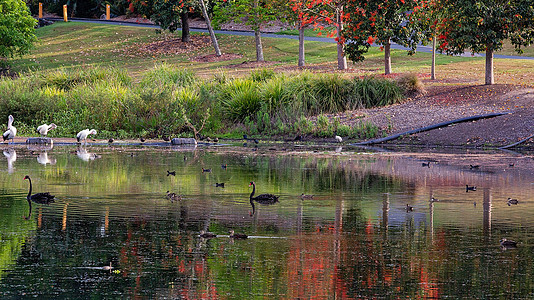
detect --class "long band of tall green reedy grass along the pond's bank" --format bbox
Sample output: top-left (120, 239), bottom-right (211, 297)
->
top-left (0, 64), bottom-right (416, 140)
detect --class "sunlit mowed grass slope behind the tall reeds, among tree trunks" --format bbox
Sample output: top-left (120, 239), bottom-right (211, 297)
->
top-left (12, 22), bottom-right (534, 84)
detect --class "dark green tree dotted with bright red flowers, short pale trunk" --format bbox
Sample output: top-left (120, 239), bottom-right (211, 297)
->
top-left (343, 0), bottom-right (424, 75)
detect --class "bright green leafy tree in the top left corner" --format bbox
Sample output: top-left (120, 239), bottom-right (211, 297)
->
top-left (0, 0), bottom-right (37, 60)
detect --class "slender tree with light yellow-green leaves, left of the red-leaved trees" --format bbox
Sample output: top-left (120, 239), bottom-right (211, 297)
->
top-left (213, 0), bottom-right (277, 62)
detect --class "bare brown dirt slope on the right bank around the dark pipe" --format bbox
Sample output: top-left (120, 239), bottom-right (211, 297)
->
top-left (344, 85), bottom-right (534, 147)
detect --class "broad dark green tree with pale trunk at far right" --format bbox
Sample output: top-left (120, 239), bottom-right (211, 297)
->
top-left (438, 0), bottom-right (534, 85)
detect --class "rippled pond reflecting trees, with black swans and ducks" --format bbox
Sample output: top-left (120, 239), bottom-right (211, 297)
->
top-left (0, 145), bottom-right (534, 299)
